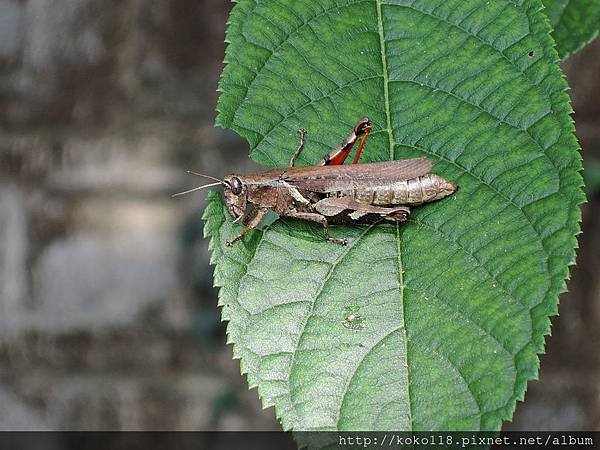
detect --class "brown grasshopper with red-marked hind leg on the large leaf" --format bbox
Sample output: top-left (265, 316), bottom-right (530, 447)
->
top-left (175, 117), bottom-right (458, 246)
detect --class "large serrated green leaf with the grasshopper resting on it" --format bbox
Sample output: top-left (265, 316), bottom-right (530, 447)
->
top-left (209, 0), bottom-right (584, 430)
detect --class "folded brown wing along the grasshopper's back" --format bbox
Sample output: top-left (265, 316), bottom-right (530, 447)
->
top-left (282, 158), bottom-right (433, 192)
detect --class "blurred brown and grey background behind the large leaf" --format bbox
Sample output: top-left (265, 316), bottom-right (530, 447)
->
top-left (0, 0), bottom-right (600, 430)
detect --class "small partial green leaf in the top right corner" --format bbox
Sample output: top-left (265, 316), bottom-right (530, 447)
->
top-left (543, 0), bottom-right (600, 59)
